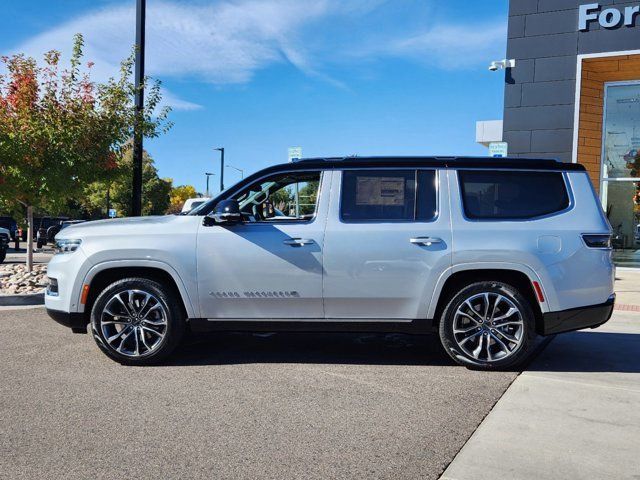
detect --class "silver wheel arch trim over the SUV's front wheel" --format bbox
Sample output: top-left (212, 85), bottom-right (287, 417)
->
top-left (78, 261), bottom-right (198, 318)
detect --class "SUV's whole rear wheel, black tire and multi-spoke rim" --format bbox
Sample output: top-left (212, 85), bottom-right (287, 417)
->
top-left (440, 281), bottom-right (536, 370)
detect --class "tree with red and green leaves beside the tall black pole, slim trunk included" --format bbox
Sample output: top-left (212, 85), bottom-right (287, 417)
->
top-left (0, 34), bottom-right (171, 268)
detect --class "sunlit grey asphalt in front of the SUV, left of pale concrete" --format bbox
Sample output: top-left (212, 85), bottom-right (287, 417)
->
top-left (0, 309), bottom-right (516, 479)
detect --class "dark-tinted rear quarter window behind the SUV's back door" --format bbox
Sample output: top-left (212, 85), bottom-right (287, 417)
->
top-left (458, 170), bottom-right (570, 220)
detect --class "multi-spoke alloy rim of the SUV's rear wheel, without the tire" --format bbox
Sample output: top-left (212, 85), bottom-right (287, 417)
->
top-left (453, 292), bottom-right (525, 362)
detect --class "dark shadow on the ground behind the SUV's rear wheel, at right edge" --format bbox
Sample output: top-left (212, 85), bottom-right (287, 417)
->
top-left (527, 330), bottom-right (640, 373)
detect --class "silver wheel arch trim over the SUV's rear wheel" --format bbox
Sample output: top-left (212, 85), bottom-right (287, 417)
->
top-left (428, 265), bottom-right (548, 326)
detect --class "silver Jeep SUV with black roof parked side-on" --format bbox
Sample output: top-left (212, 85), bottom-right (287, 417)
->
top-left (46, 157), bottom-right (615, 369)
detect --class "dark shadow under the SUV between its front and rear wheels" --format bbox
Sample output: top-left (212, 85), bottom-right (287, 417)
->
top-left (166, 332), bottom-right (455, 366)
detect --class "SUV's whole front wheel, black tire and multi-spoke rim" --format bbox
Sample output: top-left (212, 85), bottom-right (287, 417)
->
top-left (91, 278), bottom-right (185, 365)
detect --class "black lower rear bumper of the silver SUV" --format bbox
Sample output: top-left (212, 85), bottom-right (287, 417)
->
top-left (539, 294), bottom-right (616, 335)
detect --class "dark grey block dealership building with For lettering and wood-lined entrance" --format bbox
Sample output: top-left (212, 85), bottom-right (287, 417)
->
top-left (477, 0), bottom-right (640, 266)
